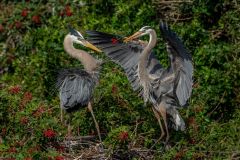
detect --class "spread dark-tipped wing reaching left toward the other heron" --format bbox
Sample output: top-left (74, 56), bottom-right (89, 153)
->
top-left (86, 31), bottom-right (162, 94)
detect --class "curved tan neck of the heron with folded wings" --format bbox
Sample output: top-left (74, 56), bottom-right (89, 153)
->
top-left (63, 35), bottom-right (98, 72)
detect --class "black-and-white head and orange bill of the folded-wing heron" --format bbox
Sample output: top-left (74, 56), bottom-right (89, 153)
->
top-left (68, 25), bottom-right (102, 52)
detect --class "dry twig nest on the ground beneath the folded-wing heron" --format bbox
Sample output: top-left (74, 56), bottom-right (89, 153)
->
top-left (51, 136), bottom-right (158, 160)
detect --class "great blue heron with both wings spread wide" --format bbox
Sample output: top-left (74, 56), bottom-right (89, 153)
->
top-left (87, 23), bottom-right (193, 142)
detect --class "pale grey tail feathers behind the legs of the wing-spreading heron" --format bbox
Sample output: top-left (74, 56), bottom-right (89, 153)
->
top-left (167, 108), bottom-right (186, 131)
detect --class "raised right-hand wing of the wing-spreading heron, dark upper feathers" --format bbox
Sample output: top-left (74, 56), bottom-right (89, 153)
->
top-left (160, 23), bottom-right (193, 106)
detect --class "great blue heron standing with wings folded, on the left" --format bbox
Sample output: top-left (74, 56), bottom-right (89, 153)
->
top-left (56, 26), bottom-right (102, 142)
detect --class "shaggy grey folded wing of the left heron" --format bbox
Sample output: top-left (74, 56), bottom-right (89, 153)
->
top-left (56, 68), bottom-right (96, 110)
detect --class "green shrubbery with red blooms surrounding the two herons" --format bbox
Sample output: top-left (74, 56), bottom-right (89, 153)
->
top-left (0, 0), bottom-right (240, 160)
